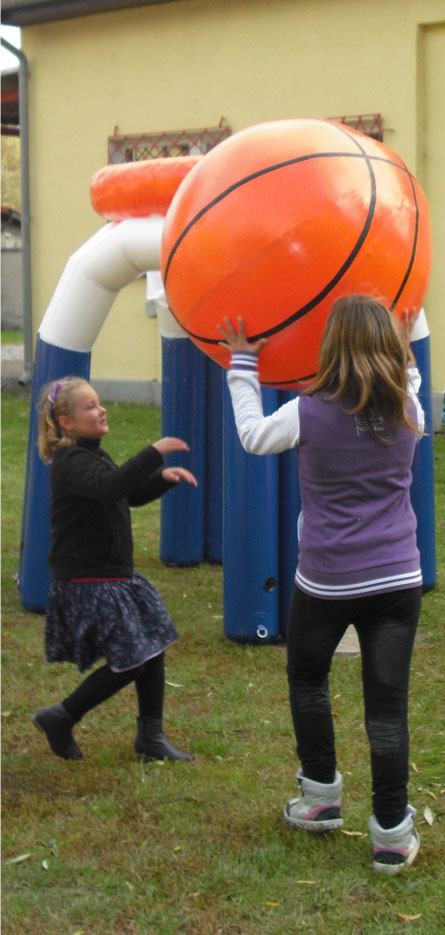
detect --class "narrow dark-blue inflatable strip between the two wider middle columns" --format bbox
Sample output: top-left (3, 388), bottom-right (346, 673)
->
top-left (204, 357), bottom-right (225, 564)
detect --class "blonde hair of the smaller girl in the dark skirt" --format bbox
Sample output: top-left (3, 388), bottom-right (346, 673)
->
top-left (39, 377), bottom-right (90, 462)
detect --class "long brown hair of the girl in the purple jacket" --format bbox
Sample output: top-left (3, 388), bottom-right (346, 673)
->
top-left (306, 295), bottom-right (416, 441)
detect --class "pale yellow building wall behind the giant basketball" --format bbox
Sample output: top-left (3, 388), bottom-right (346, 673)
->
top-left (22, 0), bottom-right (445, 392)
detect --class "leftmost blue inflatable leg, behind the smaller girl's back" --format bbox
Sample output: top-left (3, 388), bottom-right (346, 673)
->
top-left (18, 337), bottom-right (91, 613)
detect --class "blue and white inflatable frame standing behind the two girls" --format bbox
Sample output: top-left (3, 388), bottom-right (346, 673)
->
top-left (19, 152), bottom-right (436, 643)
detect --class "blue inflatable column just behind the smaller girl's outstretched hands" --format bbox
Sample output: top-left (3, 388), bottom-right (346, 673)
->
top-left (160, 337), bottom-right (206, 566)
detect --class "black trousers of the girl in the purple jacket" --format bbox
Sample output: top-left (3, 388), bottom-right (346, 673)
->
top-left (287, 587), bottom-right (422, 828)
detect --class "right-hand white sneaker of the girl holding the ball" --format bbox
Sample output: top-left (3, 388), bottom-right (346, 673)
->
top-left (369, 805), bottom-right (420, 874)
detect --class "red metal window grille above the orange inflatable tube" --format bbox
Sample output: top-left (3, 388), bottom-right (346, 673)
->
top-left (108, 117), bottom-right (232, 164)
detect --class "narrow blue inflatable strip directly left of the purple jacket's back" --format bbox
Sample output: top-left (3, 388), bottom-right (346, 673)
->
top-left (278, 390), bottom-right (301, 639)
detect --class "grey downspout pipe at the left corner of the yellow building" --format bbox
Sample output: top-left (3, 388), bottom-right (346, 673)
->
top-left (1, 37), bottom-right (33, 386)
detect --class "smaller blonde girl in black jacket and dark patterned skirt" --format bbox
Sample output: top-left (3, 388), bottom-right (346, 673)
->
top-left (33, 377), bottom-right (196, 761)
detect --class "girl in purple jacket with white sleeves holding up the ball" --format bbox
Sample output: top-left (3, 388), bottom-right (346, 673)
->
top-left (220, 295), bottom-right (423, 874)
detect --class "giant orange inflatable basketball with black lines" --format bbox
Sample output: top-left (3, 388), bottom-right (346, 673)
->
top-left (162, 119), bottom-right (432, 388)
